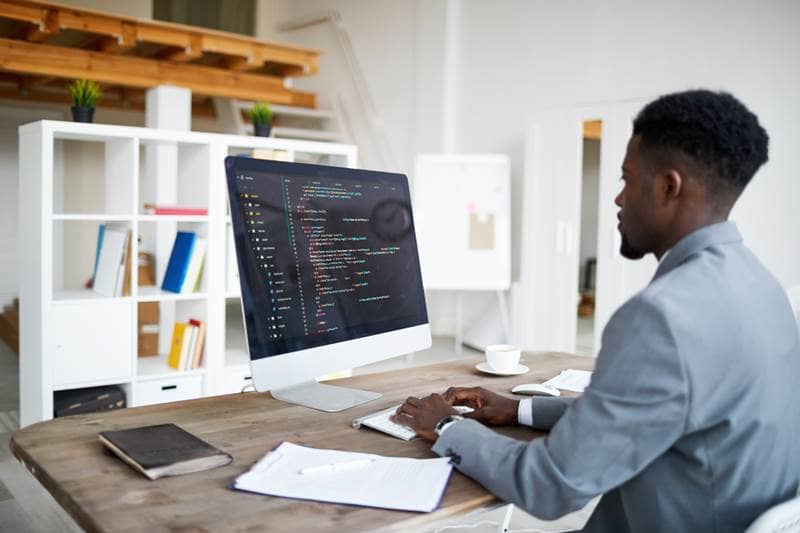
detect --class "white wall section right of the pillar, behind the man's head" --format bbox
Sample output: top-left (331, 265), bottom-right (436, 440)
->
top-left (457, 0), bottom-right (800, 294)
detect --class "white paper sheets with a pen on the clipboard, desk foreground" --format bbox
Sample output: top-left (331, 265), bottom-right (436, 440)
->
top-left (233, 442), bottom-right (453, 512)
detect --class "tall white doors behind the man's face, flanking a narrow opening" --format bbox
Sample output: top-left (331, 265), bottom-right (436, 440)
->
top-left (513, 98), bottom-right (657, 355)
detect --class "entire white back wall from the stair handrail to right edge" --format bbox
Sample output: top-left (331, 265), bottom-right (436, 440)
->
top-left (261, 0), bottom-right (800, 334)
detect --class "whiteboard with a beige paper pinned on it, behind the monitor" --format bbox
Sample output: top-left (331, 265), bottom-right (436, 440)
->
top-left (414, 154), bottom-right (511, 290)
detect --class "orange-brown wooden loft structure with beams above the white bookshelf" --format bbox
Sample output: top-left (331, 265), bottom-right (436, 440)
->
top-left (0, 0), bottom-right (320, 114)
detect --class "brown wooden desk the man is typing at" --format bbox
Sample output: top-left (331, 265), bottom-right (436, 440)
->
top-left (11, 353), bottom-right (594, 532)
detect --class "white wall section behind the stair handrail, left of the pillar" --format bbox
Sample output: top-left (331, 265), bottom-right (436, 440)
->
top-left (268, 0), bottom-right (417, 172)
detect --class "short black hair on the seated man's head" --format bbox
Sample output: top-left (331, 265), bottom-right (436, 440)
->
top-left (633, 90), bottom-right (769, 197)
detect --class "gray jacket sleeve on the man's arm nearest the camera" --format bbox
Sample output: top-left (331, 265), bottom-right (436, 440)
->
top-left (433, 298), bottom-right (689, 519)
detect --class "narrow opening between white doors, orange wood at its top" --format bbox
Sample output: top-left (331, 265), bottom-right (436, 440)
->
top-left (575, 120), bottom-right (603, 356)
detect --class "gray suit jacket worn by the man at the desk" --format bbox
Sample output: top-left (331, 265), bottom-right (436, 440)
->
top-left (433, 222), bottom-right (800, 532)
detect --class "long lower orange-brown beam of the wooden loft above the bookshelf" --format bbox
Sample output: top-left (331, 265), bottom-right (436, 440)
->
top-left (0, 39), bottom-right (316, 107)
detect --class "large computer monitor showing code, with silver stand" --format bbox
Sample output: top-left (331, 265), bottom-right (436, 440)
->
top-left (225, 156), bottom-right (431, 411)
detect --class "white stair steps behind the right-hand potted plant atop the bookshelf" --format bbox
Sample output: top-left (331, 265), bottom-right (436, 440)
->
top-left (214, 98), bottom-right (352, 143)
